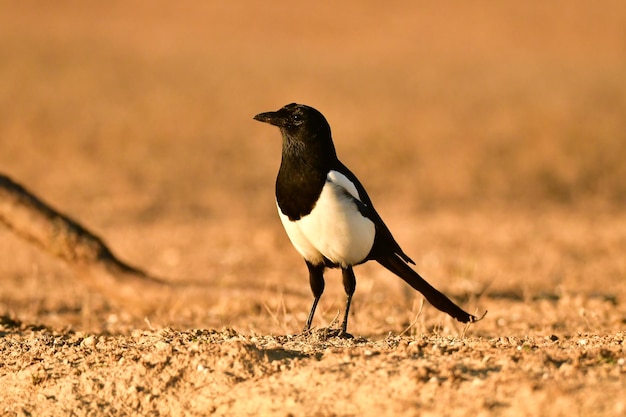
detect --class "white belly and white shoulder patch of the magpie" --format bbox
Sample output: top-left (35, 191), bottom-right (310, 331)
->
top-left (278, 171), bottom-right (376, 267)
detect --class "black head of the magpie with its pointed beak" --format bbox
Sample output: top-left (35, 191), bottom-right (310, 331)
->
top-left (254, 103), bottom-right (335, 156)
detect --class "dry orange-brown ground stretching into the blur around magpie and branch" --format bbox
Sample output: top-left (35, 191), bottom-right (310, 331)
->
top-left (0, 0), bottom-right (626, 417)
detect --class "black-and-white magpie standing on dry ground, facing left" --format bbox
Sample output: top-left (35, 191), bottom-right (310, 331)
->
top-left (254, 103), bottom-right (478, 335)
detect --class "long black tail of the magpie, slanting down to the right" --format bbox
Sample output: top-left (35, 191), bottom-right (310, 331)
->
top-left (376, 254), bottom-right (479, 323)
